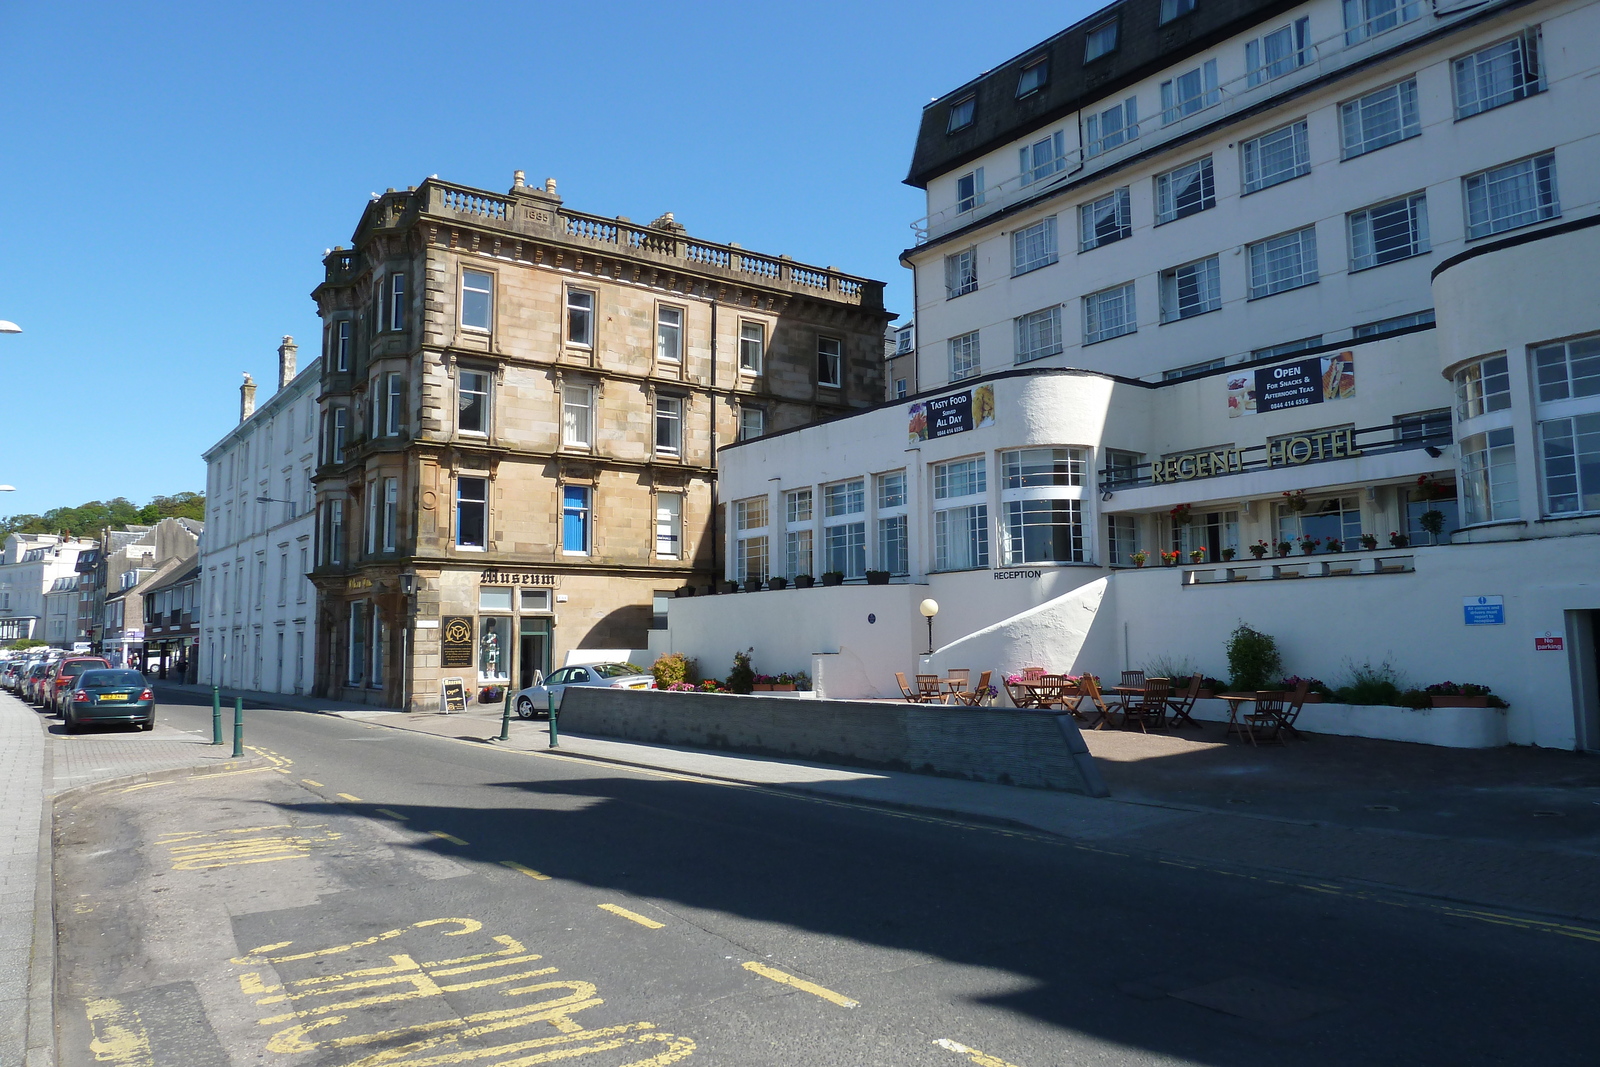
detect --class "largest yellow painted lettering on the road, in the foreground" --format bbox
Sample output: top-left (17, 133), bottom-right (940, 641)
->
top-left (228, 918), bottom-right (696, 1067)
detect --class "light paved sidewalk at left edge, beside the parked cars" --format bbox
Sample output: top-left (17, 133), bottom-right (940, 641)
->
top-left (0, 693), bottom-right (262, 1067)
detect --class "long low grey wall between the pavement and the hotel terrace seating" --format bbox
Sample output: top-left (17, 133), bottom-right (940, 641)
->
top-left (560, 686), bottom-right (1109, 797)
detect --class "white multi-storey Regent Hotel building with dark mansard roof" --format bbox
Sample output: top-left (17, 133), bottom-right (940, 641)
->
top-left (658, 0), bottom-right (1600, 749)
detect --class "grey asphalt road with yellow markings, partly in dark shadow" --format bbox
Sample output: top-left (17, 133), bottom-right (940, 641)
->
top-left (56, 705), bottom-right (1600, 1067)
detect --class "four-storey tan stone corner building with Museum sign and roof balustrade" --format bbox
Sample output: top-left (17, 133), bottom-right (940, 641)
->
top-left (312, 171), bottom-right (891, 710)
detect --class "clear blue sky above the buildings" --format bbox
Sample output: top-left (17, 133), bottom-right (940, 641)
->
top-left (0, 0), bottom-right (1099, 514)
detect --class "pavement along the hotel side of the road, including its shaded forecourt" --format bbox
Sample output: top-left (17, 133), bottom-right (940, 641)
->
top-left (159, 693), bottom-right (1600, 921)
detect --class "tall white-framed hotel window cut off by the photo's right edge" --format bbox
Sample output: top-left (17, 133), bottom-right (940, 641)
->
top-left (1531, 334), bottom-right (1600, 515)
